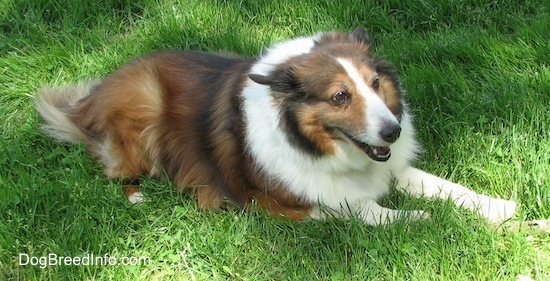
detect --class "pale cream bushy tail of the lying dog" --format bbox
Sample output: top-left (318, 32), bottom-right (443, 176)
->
top-left (36, 80), bottom-right (99, 142)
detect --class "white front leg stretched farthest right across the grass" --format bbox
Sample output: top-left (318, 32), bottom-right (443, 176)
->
top-left (396, 167), bottom-right (517, 223)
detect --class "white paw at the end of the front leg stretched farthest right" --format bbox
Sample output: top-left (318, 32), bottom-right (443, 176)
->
top-left (477, 195), bottom-right (517, 224)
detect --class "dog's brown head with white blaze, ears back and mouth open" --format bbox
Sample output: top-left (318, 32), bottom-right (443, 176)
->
top-left (249, 28), bottom-right (404, 161)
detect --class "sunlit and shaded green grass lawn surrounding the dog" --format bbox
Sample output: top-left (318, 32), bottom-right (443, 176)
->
top-left (0, 0), bottom-right (550, 280)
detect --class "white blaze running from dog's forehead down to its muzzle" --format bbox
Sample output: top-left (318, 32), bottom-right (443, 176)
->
top-left (337, 58), bottom-right (398, 146)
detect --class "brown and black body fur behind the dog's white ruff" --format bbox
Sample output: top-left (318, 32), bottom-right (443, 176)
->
top-left (39, 51), bottom-right (310, 219)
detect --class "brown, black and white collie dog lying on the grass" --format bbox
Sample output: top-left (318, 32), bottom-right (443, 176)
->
top-left (36, 28), bottom-right (516, 225)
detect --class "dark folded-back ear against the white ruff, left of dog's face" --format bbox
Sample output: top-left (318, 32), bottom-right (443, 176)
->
top-left (248, 67), bottom-right (299, 93)
